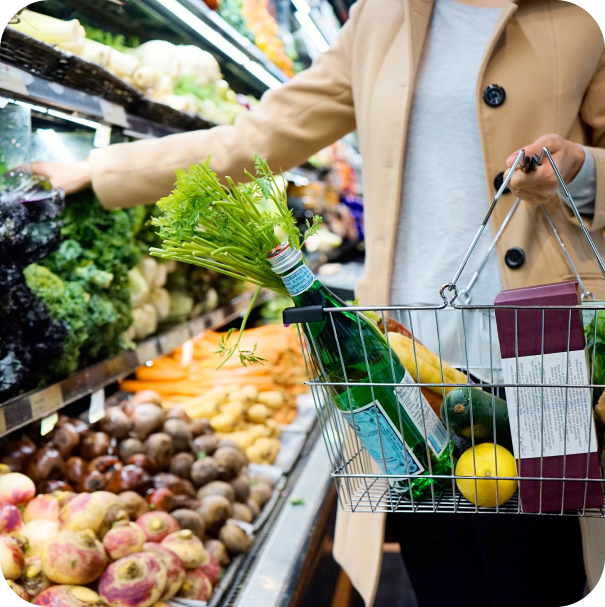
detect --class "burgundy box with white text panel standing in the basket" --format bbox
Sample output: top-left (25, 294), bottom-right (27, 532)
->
top-left (494, 281), bottom-right (603, 512)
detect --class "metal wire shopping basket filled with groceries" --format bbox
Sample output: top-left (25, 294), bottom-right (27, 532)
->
top-left (284, 148), bottom-right (605, 517)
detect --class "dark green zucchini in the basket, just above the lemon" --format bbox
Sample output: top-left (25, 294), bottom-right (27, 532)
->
top-left (441, 388), bottom-right (513, 450)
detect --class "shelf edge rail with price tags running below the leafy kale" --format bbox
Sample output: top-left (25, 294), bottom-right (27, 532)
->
top-left (0, 291), bottom-right (274, 438)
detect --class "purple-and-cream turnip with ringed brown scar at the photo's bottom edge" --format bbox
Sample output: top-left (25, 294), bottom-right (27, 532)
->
top-left (99, 552), bottom-right (167, 607)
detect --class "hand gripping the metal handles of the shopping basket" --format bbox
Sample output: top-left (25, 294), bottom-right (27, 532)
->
top-left (506, 135), bottom-right (586, 206)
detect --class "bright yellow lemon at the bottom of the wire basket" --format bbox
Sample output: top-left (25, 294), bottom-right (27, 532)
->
top-left (456, 443), bottom-right (517, 508)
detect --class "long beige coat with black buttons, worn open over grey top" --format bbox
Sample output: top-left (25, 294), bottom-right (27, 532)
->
top-left (91, 0), bottom-right (605, 603)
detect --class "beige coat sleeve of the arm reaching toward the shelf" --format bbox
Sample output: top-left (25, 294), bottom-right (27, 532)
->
top-left (90, 0), bottom-right (364, 209)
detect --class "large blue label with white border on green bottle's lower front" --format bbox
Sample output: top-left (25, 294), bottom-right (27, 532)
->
top-left (340, 400), bottom-right (424, 476)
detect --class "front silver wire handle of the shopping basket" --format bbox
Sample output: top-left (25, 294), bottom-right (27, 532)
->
top-left (439, 147), bottom-right (605, 306)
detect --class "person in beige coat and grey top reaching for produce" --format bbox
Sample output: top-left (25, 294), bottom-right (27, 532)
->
top-left (34, 0), bottom-right (605, 607)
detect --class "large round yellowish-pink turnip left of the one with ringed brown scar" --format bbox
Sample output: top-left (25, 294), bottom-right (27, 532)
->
top-left (42, 530), bottom-right (107, 585)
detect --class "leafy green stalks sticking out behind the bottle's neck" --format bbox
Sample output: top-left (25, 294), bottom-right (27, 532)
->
top-left (149, 156), bottom-right (321, 366)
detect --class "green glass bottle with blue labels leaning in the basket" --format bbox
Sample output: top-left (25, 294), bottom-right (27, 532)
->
top-left (268, 242), bottom-right (453, 500)
